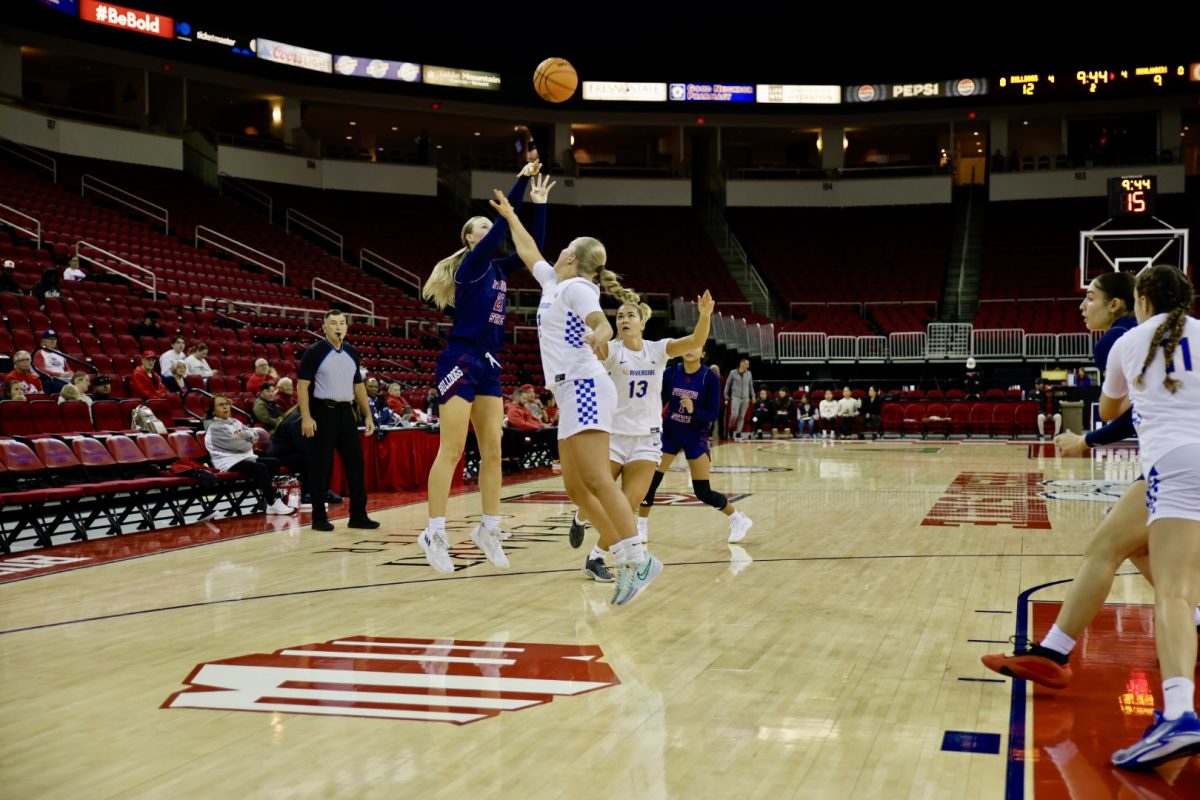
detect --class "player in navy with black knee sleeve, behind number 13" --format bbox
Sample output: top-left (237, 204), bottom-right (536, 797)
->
top-left (638, 348), bottom-right (754, 542)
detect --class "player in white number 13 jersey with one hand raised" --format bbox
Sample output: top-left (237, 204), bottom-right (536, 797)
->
top-left (570, 289), bottom-right (716, 582)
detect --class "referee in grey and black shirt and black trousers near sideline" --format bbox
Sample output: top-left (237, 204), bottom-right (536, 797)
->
top-left (296, 309), bottom-right (379, 530)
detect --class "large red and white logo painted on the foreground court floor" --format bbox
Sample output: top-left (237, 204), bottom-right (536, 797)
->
top-left (162, 636), bottom-right (620, 724)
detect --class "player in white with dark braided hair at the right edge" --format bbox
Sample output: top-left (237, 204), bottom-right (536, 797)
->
top-left (1100, 265), bottom-right (1200, 769)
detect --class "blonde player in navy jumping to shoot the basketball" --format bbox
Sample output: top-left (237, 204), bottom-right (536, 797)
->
top-left (416, 161), bottom-right (554, 572)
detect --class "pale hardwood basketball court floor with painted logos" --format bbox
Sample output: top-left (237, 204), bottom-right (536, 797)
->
top-left (0, 441), bottom-right (1180, 799)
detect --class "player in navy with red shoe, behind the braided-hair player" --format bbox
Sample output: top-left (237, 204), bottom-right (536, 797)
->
top-left (982, 272), bottom-right (1200, 688)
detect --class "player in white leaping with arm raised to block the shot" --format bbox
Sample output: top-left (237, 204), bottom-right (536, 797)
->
top-left (491, 192), bottom-right (662, 606)
